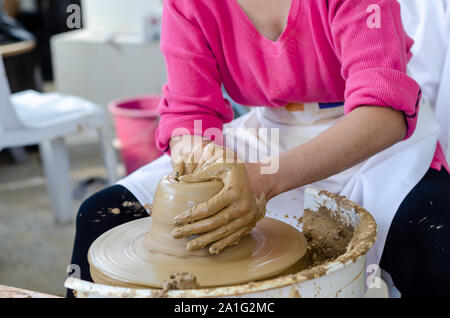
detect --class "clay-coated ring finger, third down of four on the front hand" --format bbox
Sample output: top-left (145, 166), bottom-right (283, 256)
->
top-left (186, 213), bottom-right (255, 251)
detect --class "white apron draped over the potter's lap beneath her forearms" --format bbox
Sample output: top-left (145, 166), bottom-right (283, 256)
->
top-left (118, 102), bottom-right (439, 264)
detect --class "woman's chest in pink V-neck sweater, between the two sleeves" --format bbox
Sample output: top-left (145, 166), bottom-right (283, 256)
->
top-left (203, 0), bottom-right (345, 107)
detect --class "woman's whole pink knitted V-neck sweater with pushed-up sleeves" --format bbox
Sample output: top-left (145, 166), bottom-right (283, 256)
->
top-left (156, 0), bottom-right (445, 173)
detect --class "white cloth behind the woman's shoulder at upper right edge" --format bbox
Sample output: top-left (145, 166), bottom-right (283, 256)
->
top-left (398, 0), bottom-right (450, 151)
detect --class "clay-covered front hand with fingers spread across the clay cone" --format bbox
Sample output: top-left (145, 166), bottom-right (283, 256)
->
top-left (172, 156), bottom-right (266, 254)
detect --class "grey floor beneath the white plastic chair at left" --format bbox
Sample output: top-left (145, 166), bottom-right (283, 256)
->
top-left (0, 135), bottom-right (121, 295)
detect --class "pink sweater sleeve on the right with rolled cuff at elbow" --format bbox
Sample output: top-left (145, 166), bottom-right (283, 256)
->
top-left (329, 0), bottom-right (421, 139)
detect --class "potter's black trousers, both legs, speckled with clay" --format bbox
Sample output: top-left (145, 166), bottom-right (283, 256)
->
top-left (67, 169), bottom-right (450, 297)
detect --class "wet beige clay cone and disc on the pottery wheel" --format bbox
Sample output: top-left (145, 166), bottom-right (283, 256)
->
top-left (88, 178), bottom-right (307, 288)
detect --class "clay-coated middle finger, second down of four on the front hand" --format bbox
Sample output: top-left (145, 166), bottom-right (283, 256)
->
top-left (172, 203), bottom-right (242, 239)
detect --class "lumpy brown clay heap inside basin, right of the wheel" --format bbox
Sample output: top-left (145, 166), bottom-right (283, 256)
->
top-left (303, 207), bottom-right (354, 266)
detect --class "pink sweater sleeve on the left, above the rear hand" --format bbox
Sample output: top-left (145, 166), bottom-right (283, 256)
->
top-left (156, 0), bottom-right (233, 151)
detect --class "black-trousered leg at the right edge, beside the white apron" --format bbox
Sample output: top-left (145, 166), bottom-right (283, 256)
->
top-left (381, 170), bottom-right (450, 297)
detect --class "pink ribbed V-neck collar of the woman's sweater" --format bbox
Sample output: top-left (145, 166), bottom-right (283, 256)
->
top-left (229, 0), bottom-right (301, 45)
